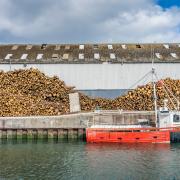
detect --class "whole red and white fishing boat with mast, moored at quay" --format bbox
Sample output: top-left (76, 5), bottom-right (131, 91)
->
top-left (86, 65), bottom-right (180, 143)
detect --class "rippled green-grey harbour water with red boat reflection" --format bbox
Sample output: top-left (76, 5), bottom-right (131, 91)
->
top-left (0, 141), bottom-right (180, 180)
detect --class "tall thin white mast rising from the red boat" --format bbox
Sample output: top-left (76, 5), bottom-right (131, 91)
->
top-left (151, 44), bottom-right (158, 127)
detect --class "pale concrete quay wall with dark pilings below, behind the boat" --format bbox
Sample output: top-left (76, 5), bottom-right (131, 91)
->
top-left (0, 111), bottom-right (154, 139)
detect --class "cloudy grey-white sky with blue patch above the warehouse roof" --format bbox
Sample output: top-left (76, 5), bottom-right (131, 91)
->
top-left (0, 0), bottom-right (180, 43)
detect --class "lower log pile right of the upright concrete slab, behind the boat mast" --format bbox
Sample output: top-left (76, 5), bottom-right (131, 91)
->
top-left (81, 78), bottom-right (180, 111)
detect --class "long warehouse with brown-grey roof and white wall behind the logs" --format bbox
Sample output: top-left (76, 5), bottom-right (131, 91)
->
top-left (0, 43), bottom-right (180, 98)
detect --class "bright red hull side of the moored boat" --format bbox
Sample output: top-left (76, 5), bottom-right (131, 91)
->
top-left (86, 128), bottom-right (171, 143)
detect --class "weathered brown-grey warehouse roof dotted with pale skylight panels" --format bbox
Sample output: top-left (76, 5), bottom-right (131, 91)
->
top-left (0, 43), bottom-right (180, 63)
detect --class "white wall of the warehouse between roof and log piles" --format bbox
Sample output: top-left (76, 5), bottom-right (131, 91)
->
top-left (0, 63), bottom-right (180, 90)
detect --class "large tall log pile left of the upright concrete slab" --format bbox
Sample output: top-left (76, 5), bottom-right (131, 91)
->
top-left (0, 69), bottom-right (73, 116)
